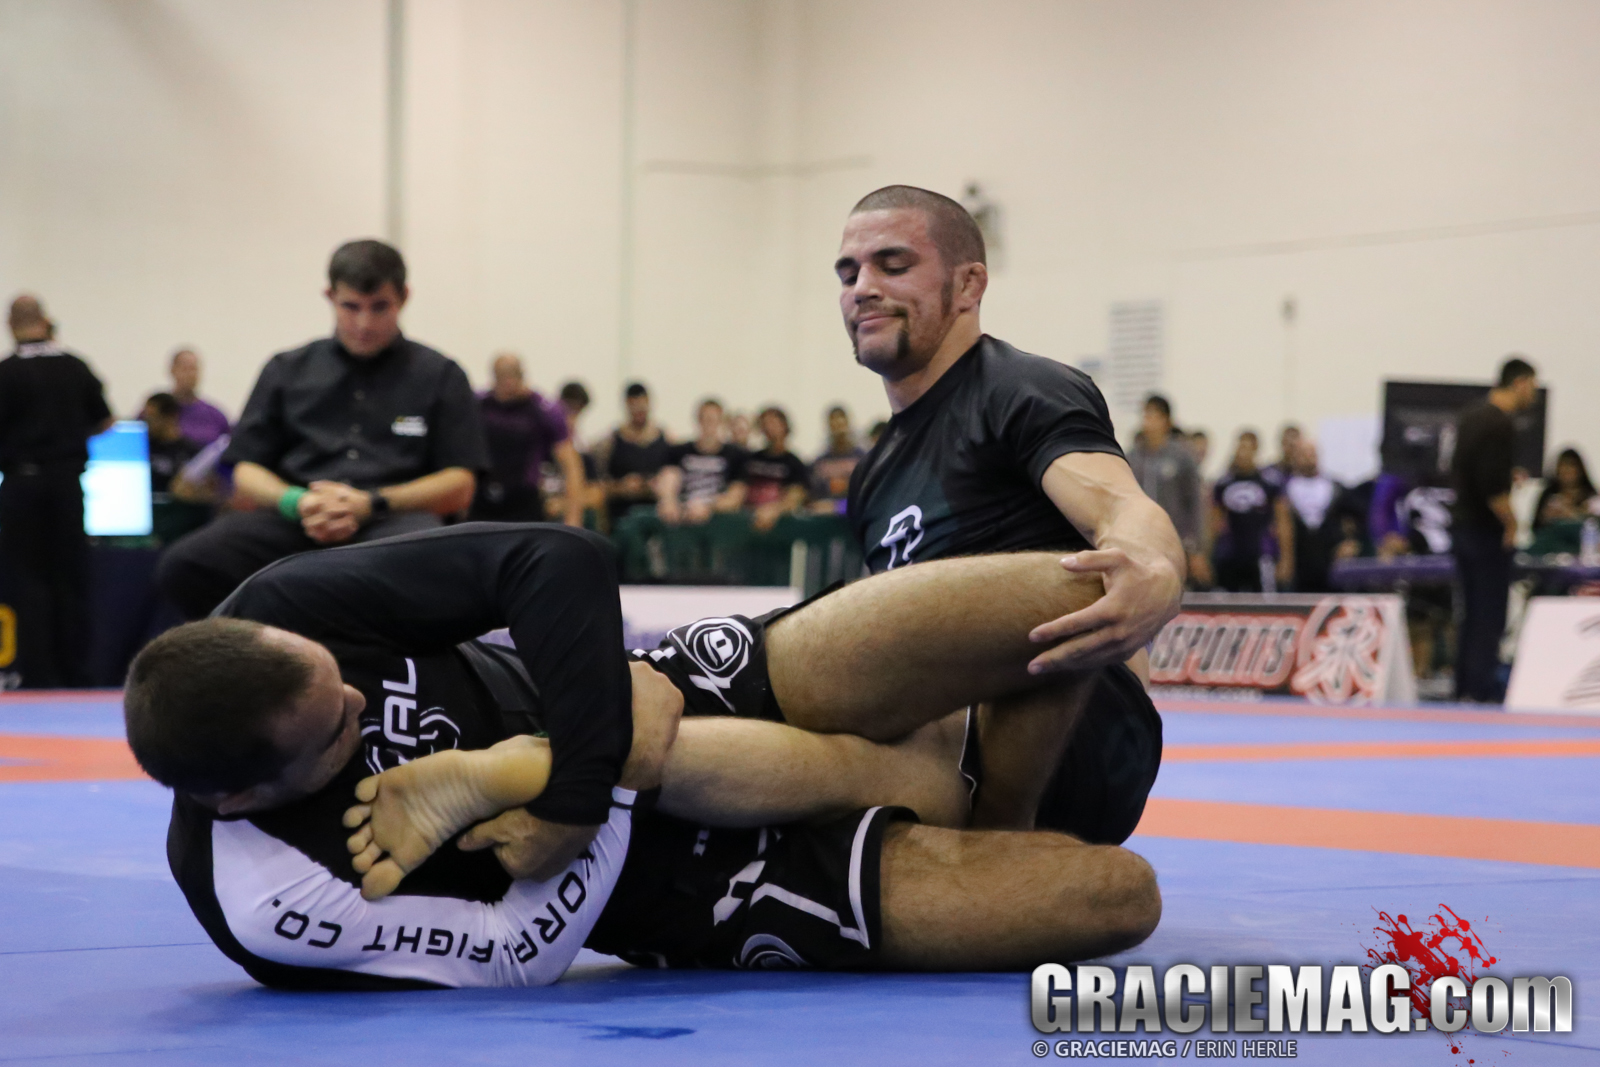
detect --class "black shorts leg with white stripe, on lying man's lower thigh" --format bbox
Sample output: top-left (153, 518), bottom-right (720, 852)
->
top-left (586, 808), bottom-right (917, 971)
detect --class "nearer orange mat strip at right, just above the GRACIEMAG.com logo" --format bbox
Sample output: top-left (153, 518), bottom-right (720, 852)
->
top-left (1138, 797), bottom-right (1600, 869)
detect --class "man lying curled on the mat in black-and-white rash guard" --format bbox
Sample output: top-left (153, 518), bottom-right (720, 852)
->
top-left (125, 523), bottom-right (1160, 989)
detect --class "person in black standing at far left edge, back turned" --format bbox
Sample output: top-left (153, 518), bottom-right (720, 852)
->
top-left (0, 294), bottom-right (112, 688)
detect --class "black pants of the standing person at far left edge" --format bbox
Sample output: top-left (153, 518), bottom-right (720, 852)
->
top-left (0, 472), bottom-right (90, 689)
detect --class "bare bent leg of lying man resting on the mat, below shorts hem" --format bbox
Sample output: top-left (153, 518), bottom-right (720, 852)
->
top-left (877, 824), bottom-right (1162, 971)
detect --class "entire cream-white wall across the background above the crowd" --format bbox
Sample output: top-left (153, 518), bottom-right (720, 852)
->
top-left (0, 0), bottom-right (1600, 454)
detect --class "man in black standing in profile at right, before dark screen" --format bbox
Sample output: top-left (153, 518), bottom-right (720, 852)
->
top-left (1450, 357), bottom-right (1539, 704)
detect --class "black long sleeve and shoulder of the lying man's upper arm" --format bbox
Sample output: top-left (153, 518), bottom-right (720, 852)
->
top-left (216, 523), bottom-right (634, 825)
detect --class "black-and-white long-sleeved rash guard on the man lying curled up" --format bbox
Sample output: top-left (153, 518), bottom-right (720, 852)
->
top-left (166, 523), bottom-right (634, 989)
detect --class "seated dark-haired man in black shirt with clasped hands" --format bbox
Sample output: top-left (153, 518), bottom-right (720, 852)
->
top-left (157, 240), bottom-right (488, 617)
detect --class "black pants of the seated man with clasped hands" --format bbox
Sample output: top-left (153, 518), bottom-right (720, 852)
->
top-left (155, 510), bottom-right (440, 619)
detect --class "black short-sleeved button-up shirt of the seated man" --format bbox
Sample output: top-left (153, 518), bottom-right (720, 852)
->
top-left (224, 336), bottom-right (488, 490)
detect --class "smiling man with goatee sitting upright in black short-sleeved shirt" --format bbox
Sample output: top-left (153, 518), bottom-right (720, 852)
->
top-left (834, 186), bottom-right (1184, 840)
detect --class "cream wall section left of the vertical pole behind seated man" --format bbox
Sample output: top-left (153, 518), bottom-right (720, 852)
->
top-left (0, 0), bottom-right (382, 425)
